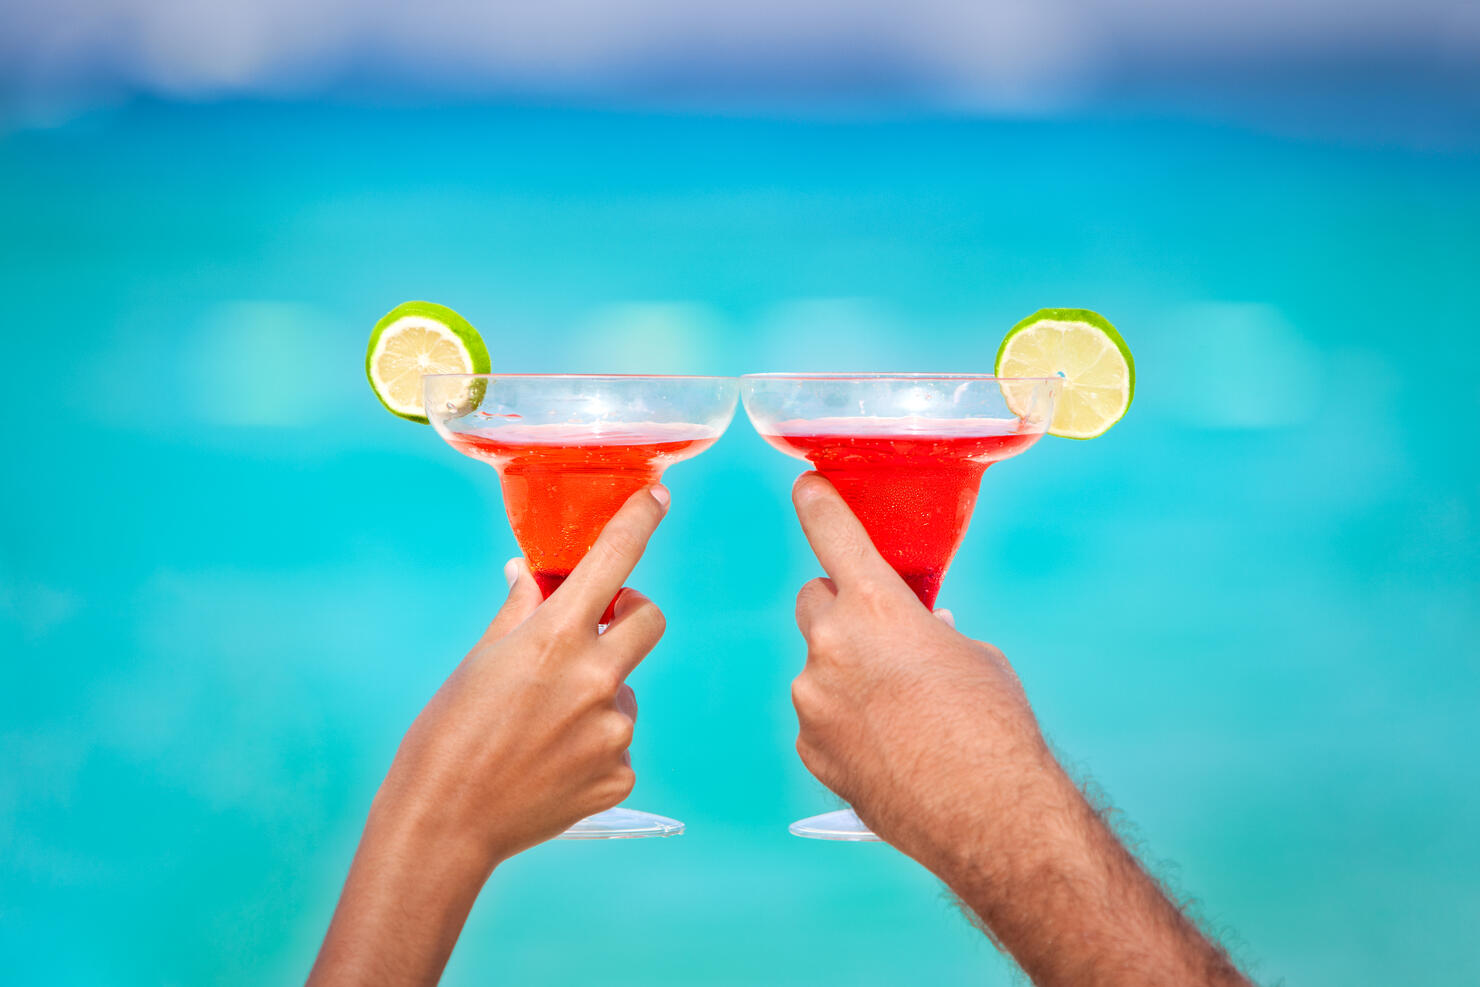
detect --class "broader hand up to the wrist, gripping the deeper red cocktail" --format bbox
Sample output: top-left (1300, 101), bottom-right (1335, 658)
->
top-left (792, 474), bottom-right (1060, 867)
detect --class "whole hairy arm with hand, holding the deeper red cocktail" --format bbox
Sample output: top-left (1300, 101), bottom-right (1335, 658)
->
top-left (792, 474), bottom-right (1249, 987)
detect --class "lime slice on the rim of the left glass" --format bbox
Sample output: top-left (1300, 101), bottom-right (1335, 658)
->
top-left (366, 302), bottom-right (490, 425)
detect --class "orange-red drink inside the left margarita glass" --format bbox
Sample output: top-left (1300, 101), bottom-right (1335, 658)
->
top-left (450, 425), bottom-right (716, 609)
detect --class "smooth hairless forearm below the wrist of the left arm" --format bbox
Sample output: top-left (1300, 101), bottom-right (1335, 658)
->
top-left (308, 792), bottom-right (493, 987)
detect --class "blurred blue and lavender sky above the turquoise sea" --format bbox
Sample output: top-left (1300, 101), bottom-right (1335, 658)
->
top-left (0, 0), bottom-right (1480, 139)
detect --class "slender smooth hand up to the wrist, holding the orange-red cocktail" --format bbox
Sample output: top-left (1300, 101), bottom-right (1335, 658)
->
top-left (377, 488), bottom-right (667, 866)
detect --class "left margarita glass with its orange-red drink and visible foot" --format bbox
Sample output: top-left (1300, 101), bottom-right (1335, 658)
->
top-left (422, 374), bottom-right (739, 839)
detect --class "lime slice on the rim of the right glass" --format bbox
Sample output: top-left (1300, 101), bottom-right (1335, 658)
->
top-left (996, 308), bottom-right (1135, 438)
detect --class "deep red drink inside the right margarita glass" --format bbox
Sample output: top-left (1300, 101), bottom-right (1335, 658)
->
top-left (765, 419), bottom-right (1042, 607)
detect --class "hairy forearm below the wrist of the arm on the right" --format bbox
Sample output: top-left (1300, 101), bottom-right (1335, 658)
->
top-left (925, 761), bottom-right (1248, 987)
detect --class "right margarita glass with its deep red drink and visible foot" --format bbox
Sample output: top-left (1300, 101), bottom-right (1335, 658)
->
top-left (740, 373), bottom-right (1063, 841)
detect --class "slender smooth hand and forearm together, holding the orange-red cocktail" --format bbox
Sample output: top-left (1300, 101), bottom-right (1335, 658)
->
top-left (308, 485), bottom-right (669, 987)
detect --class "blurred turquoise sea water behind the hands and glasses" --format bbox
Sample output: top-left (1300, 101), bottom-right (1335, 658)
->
top-left (0, 104), bottom-right (1480, 986)
